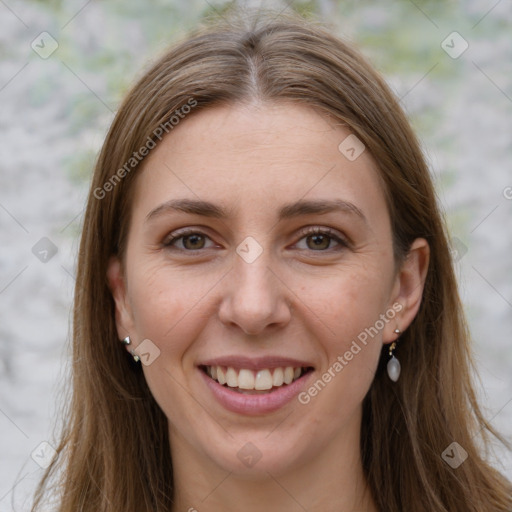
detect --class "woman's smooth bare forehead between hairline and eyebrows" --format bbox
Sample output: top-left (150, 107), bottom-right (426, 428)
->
top-left (130, 103), bottom-right (386, 225)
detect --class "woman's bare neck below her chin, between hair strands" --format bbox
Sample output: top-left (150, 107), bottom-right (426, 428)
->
top-left (171, 412), bottom-right (378, 512)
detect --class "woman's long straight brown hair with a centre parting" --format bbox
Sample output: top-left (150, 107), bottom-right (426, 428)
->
top-left (33, 9), bottom-right (512, 512)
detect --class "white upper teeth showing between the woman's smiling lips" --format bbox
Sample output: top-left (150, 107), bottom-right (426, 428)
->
top-left (199, 365), bottom-right (313, 395)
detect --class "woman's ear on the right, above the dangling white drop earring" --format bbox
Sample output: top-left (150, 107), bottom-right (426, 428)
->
top-left (383, 238), bottom-right (430, 343)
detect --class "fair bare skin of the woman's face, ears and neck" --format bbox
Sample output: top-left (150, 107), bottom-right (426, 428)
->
top-left (108, 103), bottom-right (429, 512)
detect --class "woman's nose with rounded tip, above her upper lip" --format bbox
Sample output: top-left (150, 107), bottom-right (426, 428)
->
top-left (219, 251), bottom-right (293, 335)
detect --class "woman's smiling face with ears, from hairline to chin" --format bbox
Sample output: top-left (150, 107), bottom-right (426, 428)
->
top-left (108, 104), bottom-right (426, 480)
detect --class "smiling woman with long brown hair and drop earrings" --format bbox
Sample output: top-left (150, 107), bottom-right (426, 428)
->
top-left (34, 8), bottom-right (512, 512)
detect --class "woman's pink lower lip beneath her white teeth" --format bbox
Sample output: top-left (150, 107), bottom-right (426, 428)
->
top-left (198, 369), bottom-right (313, 416)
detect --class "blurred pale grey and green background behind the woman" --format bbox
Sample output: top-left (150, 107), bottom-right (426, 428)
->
top-left (0, 0), bottom-right (512, 511)
